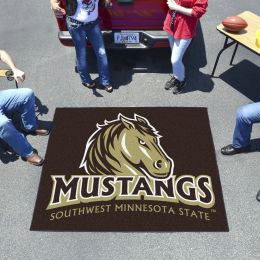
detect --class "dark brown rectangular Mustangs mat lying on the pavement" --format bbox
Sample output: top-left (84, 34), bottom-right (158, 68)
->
top-left (31, 107), bottom-right (228, 231)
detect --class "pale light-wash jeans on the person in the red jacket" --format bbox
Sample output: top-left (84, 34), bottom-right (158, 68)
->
top-left (168, 35), bottom-right (192, 81)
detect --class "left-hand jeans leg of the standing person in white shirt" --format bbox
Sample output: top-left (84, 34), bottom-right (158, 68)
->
top-left (66, 17), bottom-right (92, 84)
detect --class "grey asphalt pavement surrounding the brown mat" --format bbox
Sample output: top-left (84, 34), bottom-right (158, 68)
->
top-left (0, 0), bottom-right (260, 259)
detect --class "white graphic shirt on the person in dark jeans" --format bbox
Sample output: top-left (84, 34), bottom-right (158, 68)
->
top-left (71, 0), bottom-right (99, 23)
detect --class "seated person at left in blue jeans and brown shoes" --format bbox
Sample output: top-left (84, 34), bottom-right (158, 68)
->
top-left (0, 50), bottom-right (49, 166)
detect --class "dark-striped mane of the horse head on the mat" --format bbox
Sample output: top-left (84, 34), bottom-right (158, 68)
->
top-left (80, 114), bottom-right (160, 175)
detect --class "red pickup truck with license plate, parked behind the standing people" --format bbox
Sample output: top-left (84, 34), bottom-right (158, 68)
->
top-left (57, 0), bottom-right (169, 49)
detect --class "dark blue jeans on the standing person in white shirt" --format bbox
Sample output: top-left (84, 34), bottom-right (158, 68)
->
top-left (67, 17), bottom-right (110, 86)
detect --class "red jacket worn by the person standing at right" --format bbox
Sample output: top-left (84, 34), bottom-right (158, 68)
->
top-left (163, 0), bottom-right (208, 39)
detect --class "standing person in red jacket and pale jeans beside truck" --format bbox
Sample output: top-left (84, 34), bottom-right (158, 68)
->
top-left (163, 0), bottom-right (208, 94)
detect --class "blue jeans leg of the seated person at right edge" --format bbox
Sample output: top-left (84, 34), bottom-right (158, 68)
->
top-left (232, 102), bottom-right (260, 148)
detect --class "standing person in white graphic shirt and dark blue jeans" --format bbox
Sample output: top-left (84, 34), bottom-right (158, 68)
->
top-left (50, 0), bottom-right (113, 92)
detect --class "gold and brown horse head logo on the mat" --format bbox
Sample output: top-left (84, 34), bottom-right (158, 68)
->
top-left (80, 114), bottom-right (174, 179)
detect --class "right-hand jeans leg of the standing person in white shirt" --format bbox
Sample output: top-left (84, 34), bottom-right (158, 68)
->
top-left (87, 23), bottom-right (110, 86)
